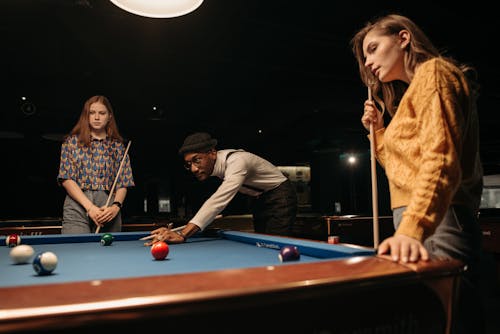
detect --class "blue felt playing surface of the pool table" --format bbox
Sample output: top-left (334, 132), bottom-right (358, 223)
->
top-left (0, 232), bottom-right (374, 287)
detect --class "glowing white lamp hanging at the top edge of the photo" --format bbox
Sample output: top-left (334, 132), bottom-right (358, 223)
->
top-left (110, 0), bottom-right (203, 18)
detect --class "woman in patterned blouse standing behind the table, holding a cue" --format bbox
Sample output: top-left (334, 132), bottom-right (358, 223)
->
top-left (57, 96), bottom-right (135, 234)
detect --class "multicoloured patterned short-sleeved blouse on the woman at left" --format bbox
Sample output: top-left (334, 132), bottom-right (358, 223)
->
top-left (57, 135), bottom-right (135, 191)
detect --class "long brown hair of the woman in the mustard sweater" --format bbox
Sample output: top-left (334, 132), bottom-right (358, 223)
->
top-left (351, 14), bottom-right (477, 116)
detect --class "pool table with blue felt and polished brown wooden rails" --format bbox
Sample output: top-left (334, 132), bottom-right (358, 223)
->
top-left (0, 230), bottom-right (463, 333)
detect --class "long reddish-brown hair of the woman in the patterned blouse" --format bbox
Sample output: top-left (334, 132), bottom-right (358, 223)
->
top-left (68, 95), bottom-right (123, 146)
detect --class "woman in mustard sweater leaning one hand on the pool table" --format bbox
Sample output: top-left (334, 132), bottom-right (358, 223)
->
top-left (351, 15), bottom-right (483, 333)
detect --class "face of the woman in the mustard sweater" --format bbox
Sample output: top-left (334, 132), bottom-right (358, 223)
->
top-left (363, 30), bottom-right (409, 82)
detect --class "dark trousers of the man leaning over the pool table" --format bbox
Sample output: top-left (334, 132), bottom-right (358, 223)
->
top-left (252, 180), bottom-right (297, 236)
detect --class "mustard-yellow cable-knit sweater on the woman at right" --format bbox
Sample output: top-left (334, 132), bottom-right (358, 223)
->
top-left (375, 58), bottom-right (483, 241)
